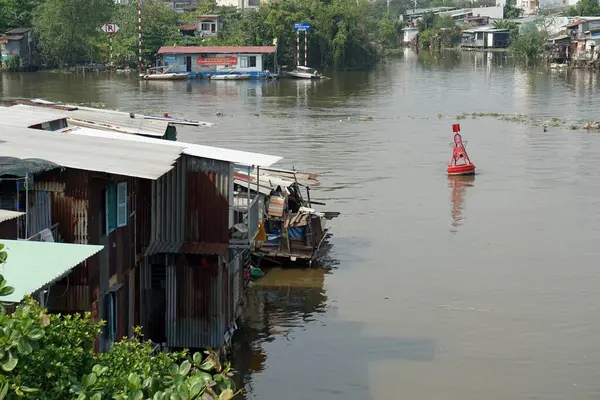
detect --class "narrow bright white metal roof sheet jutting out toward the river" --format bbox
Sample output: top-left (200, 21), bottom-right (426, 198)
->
top-left (69, 128), bottom-right (282, 167)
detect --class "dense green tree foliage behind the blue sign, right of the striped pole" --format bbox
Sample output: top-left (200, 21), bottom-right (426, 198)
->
top-left (185, 0), bottom-right (399, 68)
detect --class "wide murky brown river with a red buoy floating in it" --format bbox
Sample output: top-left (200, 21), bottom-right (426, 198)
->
top-left (0, 52), bottom-right (600, 400)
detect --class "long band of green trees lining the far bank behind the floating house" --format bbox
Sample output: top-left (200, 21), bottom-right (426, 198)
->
top-left (0, 0), bottom-right (401, 69)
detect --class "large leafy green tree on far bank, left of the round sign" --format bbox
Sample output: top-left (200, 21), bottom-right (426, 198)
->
top-left (34, 0), bottom-right (114, 65)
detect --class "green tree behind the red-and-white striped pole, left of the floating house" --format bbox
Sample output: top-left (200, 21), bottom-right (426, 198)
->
top-left (112, 0), bottom-right (181, 66)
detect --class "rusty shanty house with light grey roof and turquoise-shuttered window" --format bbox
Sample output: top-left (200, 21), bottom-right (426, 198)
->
top-left (0, 122), bottom-right (180, 350)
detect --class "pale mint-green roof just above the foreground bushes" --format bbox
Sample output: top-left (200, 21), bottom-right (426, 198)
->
top-left (0, 239), bottom-right (103, 303)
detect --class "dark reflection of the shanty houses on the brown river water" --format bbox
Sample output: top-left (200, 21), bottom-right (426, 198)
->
top-left (233, 268), bottom-right (436, 400)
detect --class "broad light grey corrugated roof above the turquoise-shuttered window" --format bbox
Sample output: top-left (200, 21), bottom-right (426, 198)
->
top-left (0, 125), bottom-right (181, 179)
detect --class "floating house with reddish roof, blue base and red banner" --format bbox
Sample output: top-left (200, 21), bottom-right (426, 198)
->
top-left (157, 46), bottom-right (276, 79)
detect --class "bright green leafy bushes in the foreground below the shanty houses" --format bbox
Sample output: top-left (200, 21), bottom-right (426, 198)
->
top-left (0, 245), bottom-right (238, 400)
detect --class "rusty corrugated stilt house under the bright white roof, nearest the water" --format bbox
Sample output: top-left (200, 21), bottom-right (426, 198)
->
top-left (63, 126), bottom-right (281, 348)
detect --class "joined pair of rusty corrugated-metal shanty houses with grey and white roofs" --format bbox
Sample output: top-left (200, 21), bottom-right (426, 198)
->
top-left (0, 105), bottom-right (280, 351)
